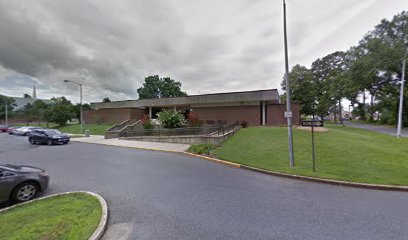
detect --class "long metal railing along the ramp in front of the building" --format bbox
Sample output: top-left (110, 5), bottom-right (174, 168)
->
top-left (119, 121), bottom-right (239, 137)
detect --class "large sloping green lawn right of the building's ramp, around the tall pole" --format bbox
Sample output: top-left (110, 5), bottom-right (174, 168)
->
top-left (213, 126), bottom-right (408, 185)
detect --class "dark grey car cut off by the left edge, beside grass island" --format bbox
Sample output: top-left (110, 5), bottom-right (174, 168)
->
top-left (0, 164), bottom-right (50, 202)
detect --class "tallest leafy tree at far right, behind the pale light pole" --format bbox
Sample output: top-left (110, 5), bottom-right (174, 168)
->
top-left (350, 11), bottom-right (408, 123)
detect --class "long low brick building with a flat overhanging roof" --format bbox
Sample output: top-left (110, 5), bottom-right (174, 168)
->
top-left (84, 89), bottom-right (300, 126)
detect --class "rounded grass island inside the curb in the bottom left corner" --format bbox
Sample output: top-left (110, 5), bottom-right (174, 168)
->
top-left (0, 193), bottom-right (102, 240)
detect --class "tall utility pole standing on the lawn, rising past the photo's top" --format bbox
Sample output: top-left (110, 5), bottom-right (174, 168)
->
top-left (283, 0), bottom-right (295, 167)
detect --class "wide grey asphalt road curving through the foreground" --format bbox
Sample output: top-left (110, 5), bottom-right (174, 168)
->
top-left (0, 134), bottom-right (408, 240)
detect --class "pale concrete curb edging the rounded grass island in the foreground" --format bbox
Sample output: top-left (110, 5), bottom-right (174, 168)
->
top-left (0, 191), bottom-right (108, 240)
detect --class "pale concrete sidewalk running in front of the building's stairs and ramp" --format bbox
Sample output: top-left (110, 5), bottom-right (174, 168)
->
top-left (71, 135), bottom-right (190, 152)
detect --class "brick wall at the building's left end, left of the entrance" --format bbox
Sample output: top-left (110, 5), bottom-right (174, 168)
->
top-left (84, 108), bottom-right (145, 124)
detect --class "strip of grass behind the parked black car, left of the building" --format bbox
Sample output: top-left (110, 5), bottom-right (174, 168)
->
top-left (14, 123), bottom-right (112, 135)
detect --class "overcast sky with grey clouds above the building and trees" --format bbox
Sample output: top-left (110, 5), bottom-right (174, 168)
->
top-left (0, 0), bottom-right (408, 102)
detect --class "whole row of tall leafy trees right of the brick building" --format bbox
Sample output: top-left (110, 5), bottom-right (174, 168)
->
top-left (281, 11), bottom-right (408, 125)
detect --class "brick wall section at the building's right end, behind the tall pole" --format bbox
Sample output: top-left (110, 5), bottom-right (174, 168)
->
top-left (266, 103), bottom-right (300, 126)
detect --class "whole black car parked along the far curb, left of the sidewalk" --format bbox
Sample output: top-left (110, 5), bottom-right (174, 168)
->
top-left (28, 129), bottom-right (70, 145)
